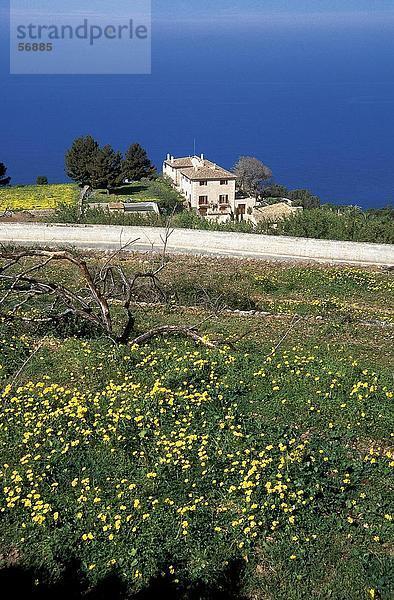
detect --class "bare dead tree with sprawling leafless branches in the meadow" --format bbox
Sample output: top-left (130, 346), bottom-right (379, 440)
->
top-left (0, 223), bottom-right (213, 346)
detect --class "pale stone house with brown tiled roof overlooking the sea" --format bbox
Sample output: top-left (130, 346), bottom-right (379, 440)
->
top-left (163, 154), bottom-right (239, 222)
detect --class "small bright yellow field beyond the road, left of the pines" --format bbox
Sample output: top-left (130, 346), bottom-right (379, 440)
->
top-left (0, 184), bottom-right (78, 211)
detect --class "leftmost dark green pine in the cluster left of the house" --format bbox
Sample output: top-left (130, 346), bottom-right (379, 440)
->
top-left (66, 135), bottom-right (100, 186)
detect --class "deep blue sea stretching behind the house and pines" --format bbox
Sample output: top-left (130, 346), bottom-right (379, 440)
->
top-left (0, 12), bottom-right (394, 207)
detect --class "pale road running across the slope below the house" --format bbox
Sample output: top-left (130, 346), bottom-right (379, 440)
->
top-left (0, 223), bottom-right (394, 265)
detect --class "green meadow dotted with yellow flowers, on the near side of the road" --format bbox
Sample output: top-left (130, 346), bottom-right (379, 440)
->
top-left (0, 256), bottom-right (393, 600)
